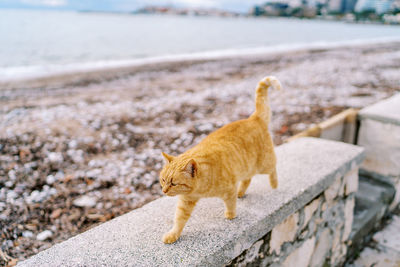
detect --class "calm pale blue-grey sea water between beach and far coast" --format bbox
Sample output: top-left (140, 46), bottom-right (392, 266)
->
top-left (0, 9), bottom-right (400, 81)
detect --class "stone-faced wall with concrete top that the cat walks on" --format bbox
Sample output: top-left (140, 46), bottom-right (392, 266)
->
top-left (19, 138), bottom-right (364, 266)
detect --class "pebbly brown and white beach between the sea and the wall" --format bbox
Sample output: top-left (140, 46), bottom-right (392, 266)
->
top-left (0, 43), bottom-right (400, 265)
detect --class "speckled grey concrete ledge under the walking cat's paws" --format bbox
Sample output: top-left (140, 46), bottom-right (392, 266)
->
top-left (18, 138), bottom-right (364, 266)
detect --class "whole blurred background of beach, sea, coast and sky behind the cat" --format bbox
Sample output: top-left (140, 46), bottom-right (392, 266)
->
top-left (0, 0), bottom-right (400, 265)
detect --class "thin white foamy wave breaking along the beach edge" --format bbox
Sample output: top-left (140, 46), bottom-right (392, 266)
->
top-left (0, 37), bottom-right (400, 82)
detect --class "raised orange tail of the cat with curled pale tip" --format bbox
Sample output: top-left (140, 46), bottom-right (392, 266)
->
top-left (253, 76), bottom-right (282, 124)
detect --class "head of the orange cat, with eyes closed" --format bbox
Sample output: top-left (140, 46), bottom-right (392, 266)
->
top-left (160, 153), bottom-right (198, 196)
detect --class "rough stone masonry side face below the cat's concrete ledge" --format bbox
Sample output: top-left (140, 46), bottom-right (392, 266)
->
top-left (229, 167), bottom-right (358, 267)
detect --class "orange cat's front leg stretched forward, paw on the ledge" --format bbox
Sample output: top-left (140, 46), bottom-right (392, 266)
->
top-left (162, 196), bottom-right (198, 244)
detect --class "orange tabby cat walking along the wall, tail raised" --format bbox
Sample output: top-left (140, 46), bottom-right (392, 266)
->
top-left (160, 77), bottom-right (281, 243)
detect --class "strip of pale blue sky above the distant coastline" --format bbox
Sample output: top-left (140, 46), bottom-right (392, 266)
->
top-left (0, 0), bottom-right (266, 12)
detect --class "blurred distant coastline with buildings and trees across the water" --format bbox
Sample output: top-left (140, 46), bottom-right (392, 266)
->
top-left (131, 4), bottom-right (400, 25)
